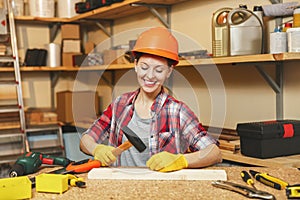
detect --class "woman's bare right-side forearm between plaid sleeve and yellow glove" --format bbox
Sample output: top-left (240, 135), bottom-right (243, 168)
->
top-left (184, 144), bottom-right (222, 168)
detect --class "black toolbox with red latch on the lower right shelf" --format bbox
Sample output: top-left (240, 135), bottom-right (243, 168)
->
top-left (236, 120), bottom-right (300, 158)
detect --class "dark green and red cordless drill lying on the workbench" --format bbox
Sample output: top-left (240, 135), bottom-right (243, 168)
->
top-left (9, 152), bottom-right (71, 177)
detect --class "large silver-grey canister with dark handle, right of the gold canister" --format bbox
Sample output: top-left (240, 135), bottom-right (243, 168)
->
top-left (227, 8), bottom-right (263, 56)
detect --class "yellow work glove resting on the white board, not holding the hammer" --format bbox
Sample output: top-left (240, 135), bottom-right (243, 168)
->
top-left (146, 151), bottom-right (188, 172)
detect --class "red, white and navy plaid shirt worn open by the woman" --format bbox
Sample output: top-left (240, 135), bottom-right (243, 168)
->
top-left (85, 89), bottom-right (217, 164)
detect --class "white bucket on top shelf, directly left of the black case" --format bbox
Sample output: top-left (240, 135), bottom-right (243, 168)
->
top-left (57, 0), bottom-right (81, 18)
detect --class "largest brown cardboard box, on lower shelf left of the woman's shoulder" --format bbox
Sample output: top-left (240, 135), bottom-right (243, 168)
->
top-left (56, 91), bottom-right (100, 123)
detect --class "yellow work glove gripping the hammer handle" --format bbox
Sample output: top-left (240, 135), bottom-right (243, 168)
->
top-left (93, 144), bottom-right (117, 166)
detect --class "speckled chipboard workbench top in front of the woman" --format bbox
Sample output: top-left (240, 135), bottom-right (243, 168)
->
top-left (32, 167), bottom-right (300, 200)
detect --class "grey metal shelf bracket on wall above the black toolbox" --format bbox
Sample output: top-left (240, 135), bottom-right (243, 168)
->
top-left (255, 62), bottom-right (283, 120)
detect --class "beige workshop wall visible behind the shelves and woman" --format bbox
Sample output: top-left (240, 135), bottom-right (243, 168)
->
top-left (2, 0), bottom-right (300, 128)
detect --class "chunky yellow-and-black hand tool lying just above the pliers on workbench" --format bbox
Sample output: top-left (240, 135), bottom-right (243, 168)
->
top-left (250, 170), bottom-right (289, 190)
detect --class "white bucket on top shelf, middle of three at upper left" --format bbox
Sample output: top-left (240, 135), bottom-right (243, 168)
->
top-left (29, 0), bottom-right (55, 17)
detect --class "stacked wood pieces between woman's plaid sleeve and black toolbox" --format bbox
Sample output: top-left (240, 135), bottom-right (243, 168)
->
top-left (204, 126), bottom-right (240, 153)
